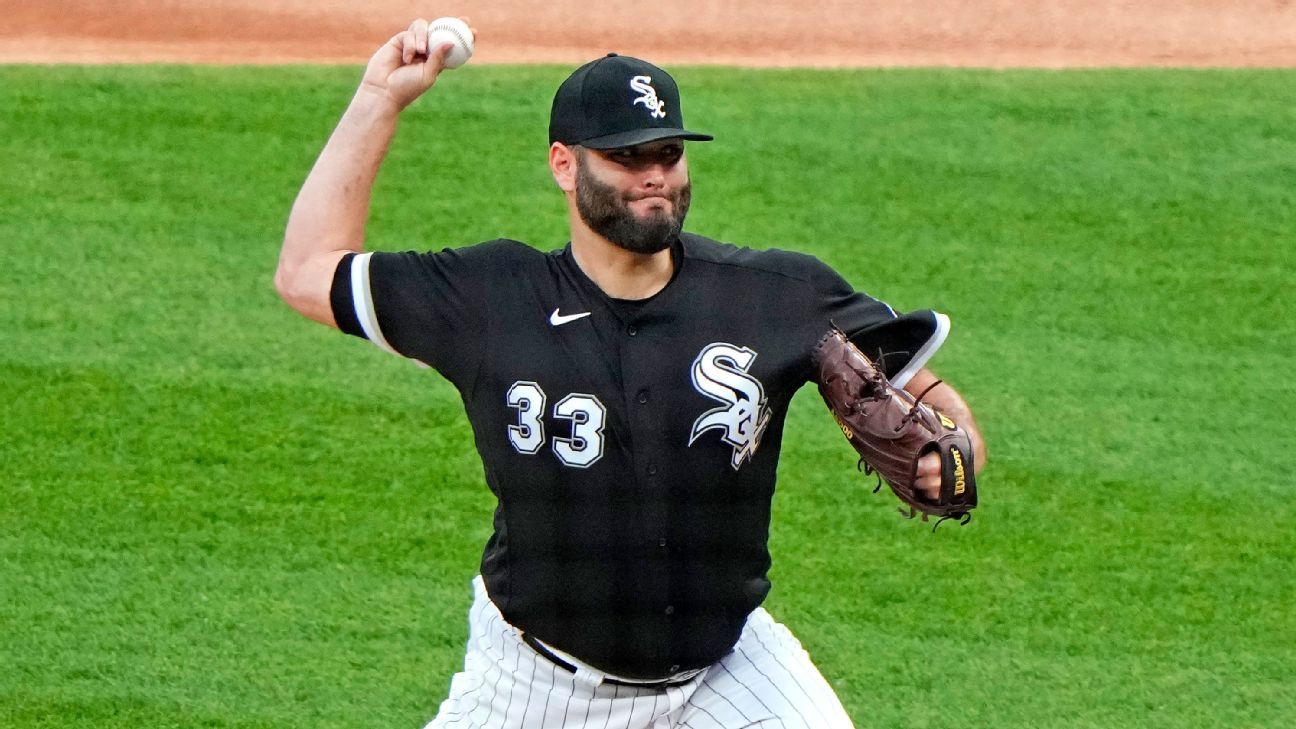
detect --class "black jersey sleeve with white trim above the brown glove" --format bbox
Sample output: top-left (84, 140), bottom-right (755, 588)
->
top-left (811, 261), bottom-right (950, 388)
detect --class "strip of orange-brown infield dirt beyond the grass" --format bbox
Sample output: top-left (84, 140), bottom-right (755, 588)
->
top-left (0, 0), bottom-right (1296, 67)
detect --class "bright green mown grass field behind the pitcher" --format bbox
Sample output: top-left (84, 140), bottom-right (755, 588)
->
top-left (0, 66), bottom-right (1296, 729)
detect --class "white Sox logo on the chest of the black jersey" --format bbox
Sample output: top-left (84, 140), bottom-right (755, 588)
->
top-left (688, 342), bottom-right (770, 471)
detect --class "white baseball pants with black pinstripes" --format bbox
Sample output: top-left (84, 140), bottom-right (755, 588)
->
top-left (425, 577), bottom-right (853, 729)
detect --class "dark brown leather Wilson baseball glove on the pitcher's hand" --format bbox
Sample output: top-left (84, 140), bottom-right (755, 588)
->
top-left (814, 329), bottom-right (976, 525)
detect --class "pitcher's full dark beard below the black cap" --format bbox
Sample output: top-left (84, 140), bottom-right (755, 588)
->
top-left (575, 165), bottom-right (693, 253)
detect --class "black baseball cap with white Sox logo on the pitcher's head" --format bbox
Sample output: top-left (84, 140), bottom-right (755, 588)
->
top-left (550, 53), bottom-right (713, 149)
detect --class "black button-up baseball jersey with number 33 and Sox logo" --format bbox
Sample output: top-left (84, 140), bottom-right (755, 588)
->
top-left (332, 233), bottom-right (947, 678)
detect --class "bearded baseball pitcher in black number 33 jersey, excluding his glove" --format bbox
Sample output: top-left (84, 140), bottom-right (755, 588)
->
top-left (275, 19), bottom-right (985, 729)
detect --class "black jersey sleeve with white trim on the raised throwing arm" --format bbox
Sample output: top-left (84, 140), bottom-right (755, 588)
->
top-left (329, 244), bottom-right (492, 384)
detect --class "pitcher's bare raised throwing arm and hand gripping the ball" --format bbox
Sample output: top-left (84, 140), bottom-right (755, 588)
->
top-left (275, 18), bottom-right (463, 327)
